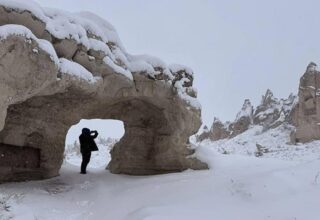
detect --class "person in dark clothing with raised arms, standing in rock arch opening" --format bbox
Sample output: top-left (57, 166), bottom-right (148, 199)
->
top-left (79, 128), bottom-right (99, 174)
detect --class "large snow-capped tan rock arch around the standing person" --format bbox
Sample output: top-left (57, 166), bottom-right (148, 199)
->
top-left (0, 0), bottom-right (207, 182)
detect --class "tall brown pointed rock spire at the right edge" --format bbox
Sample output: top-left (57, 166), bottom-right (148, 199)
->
top-left (291, 62), bottom-right (320, 143)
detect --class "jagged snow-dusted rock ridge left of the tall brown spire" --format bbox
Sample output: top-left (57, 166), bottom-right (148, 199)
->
top-left (197, 89), bottom-right (297, 141)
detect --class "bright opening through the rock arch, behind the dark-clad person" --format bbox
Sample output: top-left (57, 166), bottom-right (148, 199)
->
top-left (64, 119), bottom-right (124, 169)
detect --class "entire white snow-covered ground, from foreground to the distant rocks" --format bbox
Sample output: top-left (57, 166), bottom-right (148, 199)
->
top-left (0, 127), bottom-right (320, 220)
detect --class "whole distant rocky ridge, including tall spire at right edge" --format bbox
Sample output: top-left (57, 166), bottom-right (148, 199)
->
top-left (196, 62), bottom-right (320, 143)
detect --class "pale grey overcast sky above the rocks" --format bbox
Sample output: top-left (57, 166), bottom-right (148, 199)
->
top-left (34, 0), bottom-right (320, 141)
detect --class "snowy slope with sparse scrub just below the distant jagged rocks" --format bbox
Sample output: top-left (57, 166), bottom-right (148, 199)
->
top-left (200, 124), bottom-right (320, 161)
